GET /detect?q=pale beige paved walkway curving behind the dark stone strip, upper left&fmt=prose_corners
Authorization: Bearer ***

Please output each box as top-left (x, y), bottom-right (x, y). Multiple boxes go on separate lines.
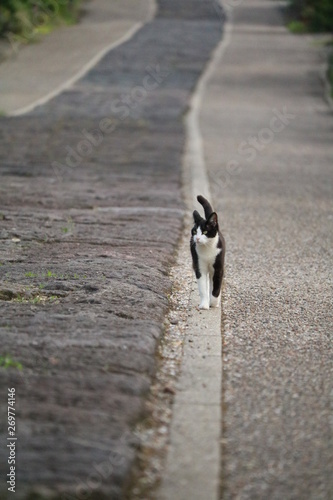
top-left (0, 0), bottom-right (155, 114)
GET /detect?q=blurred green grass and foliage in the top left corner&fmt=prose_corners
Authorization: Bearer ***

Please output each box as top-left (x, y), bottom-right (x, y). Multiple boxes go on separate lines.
top-left (0, 0), bottom-right (81, 42)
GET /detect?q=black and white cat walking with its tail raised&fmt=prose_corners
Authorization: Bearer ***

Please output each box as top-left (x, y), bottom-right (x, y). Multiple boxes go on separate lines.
top-left (191, 195), bottom-right (225, 309)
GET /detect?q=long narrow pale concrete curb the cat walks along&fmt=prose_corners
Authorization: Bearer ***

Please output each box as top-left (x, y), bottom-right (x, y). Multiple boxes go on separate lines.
top-left (158, 10), bottom-right (232, 500)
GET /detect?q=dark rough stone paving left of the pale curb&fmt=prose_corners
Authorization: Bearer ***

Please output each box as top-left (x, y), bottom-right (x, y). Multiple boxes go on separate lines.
top-left (0, 0), bottom-right (221, 499)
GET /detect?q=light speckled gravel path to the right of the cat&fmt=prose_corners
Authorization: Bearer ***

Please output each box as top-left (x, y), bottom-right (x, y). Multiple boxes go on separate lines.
top-left (201, 0), bottom-right (333, 500)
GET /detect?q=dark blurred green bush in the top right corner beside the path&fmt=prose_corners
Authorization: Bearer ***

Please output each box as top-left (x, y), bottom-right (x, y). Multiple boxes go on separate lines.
top-left (289, 0), bottom-right (333, 33)
